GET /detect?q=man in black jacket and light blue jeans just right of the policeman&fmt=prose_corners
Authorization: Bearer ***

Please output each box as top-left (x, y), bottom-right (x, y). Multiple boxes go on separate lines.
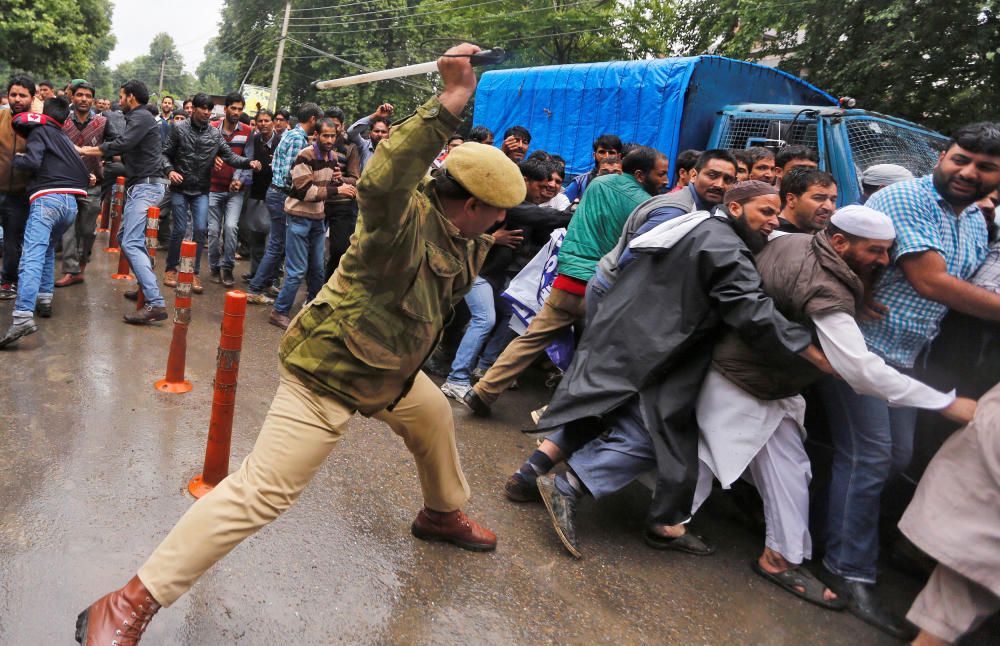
top-left (441, 159), bottom-right (572, 401)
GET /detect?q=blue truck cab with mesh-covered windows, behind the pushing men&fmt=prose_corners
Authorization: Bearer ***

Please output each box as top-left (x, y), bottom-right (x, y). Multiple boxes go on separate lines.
top-left (706, 103), bottom-right (948, 206)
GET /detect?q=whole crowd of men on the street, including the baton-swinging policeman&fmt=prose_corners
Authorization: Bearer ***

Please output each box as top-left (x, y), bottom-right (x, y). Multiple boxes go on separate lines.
top-left (0, 45), bottom-right (1000, 644)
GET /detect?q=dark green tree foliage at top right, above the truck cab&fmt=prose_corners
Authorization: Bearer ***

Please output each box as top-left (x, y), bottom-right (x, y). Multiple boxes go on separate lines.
top-left (669, 0), bottom-right (1000, 132)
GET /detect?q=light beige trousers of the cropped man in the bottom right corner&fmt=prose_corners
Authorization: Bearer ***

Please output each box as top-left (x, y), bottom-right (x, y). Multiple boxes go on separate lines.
top-left (906, 563), bottom-right (1000, 644)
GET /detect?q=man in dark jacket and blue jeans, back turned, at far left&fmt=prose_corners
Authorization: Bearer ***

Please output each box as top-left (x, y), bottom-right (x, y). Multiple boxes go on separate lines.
top-left (0, 97), bottom-right (90, 348)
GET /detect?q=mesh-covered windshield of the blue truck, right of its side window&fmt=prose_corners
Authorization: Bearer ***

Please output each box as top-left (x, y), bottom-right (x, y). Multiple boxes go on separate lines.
top-left (845, 118), bottom-right (947, 181)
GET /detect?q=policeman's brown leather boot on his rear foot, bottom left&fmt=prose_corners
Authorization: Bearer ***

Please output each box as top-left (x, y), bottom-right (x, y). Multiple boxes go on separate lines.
top-left (76, 576), bottom-right (160, 646)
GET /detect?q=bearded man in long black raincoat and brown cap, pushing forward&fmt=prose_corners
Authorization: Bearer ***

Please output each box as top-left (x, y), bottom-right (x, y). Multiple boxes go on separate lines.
top-left (528, 182), bottom-right (825, 558)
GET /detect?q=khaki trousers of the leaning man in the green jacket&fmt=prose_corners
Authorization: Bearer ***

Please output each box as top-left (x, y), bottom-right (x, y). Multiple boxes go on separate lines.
top-left (473, 289), bottom-right (586, 405)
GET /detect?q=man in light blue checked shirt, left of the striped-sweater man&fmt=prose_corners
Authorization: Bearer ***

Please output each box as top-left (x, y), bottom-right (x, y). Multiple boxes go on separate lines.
top-left (247, 103), bottom-right (323, 305)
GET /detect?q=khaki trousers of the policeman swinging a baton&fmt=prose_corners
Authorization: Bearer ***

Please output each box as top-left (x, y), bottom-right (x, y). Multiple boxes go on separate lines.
top-left (139, 368), bottom-right (469, 606)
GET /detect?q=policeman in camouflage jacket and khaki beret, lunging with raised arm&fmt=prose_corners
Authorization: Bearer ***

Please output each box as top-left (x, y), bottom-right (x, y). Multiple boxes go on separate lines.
top-left (76, 44), bottom-right (525, 645)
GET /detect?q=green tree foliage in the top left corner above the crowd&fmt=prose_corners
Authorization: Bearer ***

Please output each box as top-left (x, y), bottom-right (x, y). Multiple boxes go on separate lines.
top-left (0, 0), bottom-right (115, 82)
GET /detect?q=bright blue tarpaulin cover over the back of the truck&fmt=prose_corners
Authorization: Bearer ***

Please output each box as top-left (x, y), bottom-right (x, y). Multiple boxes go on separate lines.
top-left (473, 56), bottom-right (834, 177)
